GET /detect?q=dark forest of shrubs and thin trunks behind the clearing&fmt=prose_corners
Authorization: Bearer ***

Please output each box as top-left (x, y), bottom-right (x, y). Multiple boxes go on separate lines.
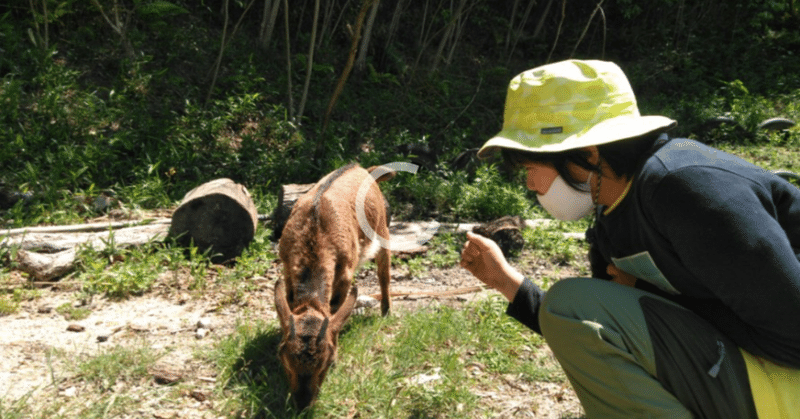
top-left (0, 0), bottom-right (800, 225)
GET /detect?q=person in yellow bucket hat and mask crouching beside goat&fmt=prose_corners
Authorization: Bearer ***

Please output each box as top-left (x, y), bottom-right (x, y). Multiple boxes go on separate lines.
top-left (461, 60), bottom-right (800, 419)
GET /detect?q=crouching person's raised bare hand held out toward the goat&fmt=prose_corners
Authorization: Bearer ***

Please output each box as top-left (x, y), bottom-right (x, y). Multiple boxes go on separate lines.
top-left (461, 232), bottom-right (525, 301)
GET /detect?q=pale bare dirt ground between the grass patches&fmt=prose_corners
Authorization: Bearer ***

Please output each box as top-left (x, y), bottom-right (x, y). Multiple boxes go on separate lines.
top-left (0, 235), bottom-right (583, 418)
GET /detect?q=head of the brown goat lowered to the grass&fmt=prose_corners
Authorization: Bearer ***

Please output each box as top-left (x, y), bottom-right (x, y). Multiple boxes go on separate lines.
top-left (275, 280), bottom-right (358, 410)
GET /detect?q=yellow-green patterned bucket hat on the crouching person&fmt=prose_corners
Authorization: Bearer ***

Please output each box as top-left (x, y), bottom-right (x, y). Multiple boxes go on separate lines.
top-left (478, 60), bottom-right (677, 157)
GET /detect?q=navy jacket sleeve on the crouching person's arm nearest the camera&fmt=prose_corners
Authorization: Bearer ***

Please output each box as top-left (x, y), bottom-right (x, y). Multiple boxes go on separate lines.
top-left (648, 167), bottom-right (800, 367)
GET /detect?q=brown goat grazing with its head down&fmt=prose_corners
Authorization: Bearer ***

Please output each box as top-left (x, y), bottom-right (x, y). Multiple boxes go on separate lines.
top-left (275, 164), bottom-right (395, 409)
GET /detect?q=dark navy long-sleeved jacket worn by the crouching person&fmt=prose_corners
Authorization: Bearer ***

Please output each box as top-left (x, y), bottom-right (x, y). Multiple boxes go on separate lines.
top-left (508, 139), bottom-right (800, 367)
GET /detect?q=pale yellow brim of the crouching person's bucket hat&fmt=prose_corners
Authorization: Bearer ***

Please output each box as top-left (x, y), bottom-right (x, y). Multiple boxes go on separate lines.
top-left (478, 115), bottom-right (678, 158)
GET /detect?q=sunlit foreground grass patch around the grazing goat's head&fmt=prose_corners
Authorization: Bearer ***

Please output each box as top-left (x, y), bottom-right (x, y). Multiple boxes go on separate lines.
top-left (209, 296), bottom-right (565, 418)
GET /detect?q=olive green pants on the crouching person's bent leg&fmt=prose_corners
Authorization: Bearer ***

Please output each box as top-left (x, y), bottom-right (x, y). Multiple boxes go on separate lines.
top-left (539, 278), bottom-right (756, 419)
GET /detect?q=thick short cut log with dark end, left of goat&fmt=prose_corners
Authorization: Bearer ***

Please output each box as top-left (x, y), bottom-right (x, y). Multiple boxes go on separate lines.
top-left (168, 178), bottom-right (258, 263)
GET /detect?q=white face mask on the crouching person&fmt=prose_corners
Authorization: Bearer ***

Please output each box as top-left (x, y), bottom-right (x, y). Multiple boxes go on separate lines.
top-left (536, 172), bottom-right (594, 221)
